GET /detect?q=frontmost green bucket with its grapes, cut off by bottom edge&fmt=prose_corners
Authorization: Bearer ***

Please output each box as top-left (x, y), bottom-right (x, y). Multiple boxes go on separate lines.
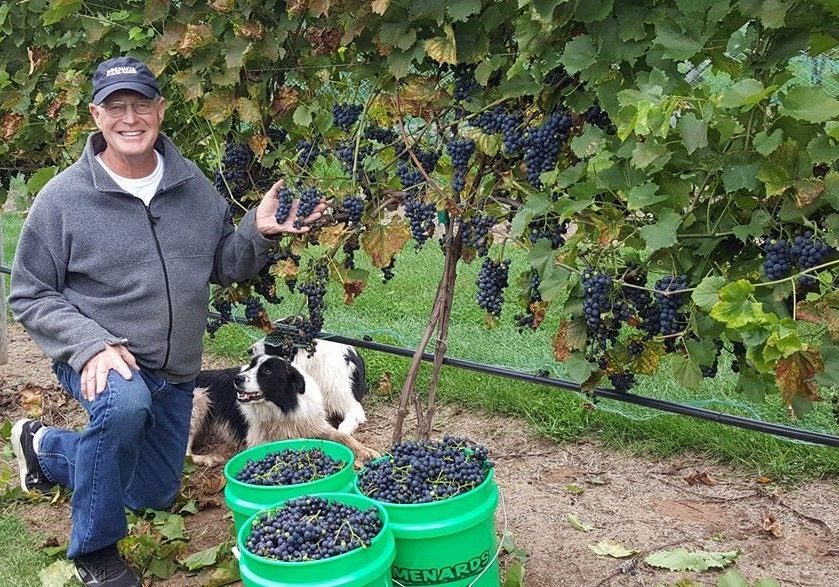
top-left (236, 493), bottom-right (396, 587)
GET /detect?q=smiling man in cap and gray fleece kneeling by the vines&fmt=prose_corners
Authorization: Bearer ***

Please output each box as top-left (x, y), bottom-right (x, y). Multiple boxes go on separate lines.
top-left (9, 57), bottom-right (324, 587)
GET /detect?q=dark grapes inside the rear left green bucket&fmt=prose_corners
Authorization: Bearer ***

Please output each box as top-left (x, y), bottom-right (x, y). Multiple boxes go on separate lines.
top-left (236, 448), bottom-right (347, 485)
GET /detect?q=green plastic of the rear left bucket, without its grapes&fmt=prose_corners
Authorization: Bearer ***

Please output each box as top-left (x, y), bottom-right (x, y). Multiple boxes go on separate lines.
top-left (224, 438), bottom-right (355, 532)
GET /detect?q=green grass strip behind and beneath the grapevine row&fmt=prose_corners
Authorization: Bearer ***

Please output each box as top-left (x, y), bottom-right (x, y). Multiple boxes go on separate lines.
top-left (4, 213), bottom-right (839, 482)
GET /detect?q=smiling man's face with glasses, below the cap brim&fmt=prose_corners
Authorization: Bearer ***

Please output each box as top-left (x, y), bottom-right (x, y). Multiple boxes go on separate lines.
top-left (89, 90), bottom-right (165, 158)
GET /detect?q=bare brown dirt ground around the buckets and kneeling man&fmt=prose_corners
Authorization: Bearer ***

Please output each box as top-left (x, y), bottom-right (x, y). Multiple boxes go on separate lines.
top-left (0, 325), bottom-right (839, 587)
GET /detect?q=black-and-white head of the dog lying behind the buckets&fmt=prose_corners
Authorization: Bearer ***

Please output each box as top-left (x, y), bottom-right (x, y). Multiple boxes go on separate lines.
top-left (233, 355), bottom-right (306, 413)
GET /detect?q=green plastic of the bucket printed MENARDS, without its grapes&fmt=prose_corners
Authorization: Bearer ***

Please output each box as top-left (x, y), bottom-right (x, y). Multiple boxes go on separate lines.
top-left (355, 469), bottom-right (501, 587)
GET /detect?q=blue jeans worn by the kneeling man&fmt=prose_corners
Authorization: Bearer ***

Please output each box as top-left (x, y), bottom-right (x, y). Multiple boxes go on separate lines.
top-left (38, 363), bottom-right (194, 559)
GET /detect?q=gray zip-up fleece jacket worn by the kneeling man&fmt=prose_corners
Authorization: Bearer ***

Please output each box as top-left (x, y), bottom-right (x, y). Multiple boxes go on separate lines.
top-left (9, 132), bottom-right (274, 383)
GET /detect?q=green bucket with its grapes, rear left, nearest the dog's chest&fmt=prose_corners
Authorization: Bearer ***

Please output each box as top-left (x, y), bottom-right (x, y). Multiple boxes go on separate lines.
top-left (224, 439), bottom-right (355, 532)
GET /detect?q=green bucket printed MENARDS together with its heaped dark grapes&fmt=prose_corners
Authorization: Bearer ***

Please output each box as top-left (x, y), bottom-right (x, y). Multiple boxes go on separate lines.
top-left (355, 437), bottom-right (501, 587)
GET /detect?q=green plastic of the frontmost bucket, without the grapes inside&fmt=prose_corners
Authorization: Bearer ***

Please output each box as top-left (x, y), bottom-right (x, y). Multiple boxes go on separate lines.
top-left (236, 493), bottom-right (395, 587)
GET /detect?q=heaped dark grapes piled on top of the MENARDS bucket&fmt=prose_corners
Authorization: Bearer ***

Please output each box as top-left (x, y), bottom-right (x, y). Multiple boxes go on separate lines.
top-left (358, 436), bottom-right (492, 503)
